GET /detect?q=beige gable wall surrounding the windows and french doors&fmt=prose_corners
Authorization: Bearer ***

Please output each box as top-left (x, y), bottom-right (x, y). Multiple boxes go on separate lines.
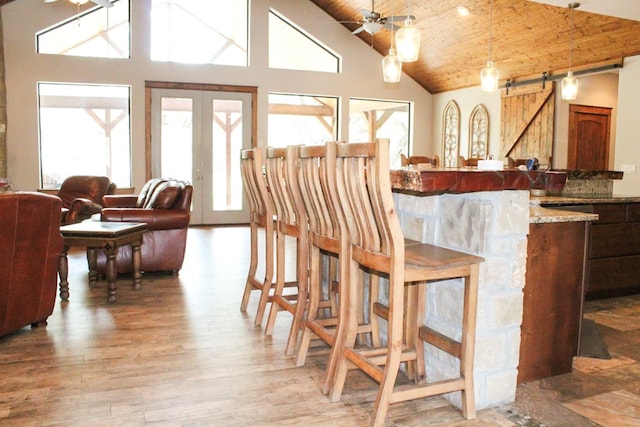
top-left (2, 0), bottom-right (432, 190)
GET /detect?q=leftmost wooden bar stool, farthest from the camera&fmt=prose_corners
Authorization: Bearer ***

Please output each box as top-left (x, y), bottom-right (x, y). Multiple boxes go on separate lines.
top-left (240, 148), bottom-right (275, 326)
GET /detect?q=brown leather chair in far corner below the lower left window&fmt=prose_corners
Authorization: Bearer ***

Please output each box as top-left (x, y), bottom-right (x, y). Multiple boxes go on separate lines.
top-left (57, 175), bottom-right (116, 225)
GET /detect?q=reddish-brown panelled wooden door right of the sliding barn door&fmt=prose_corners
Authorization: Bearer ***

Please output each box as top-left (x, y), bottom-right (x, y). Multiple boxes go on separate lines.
top-left (567, 105), bottom-right (611, 170)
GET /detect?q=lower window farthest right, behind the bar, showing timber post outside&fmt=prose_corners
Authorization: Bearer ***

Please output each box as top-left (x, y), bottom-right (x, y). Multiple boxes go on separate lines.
top-left (349, 98), bottom-right (411, 168)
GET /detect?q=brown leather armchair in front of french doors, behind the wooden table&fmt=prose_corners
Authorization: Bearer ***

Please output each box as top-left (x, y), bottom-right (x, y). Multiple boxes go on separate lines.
top-left (97, 178), bottom-right (193, 275)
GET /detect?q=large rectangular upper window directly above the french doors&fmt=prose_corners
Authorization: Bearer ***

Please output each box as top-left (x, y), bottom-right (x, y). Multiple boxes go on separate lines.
top-left (151, 0), bottom-right (249, 67)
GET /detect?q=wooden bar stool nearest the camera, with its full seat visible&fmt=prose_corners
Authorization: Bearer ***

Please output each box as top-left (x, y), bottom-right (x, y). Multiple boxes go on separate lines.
top-left (327, 140), bottom-right (484, 426)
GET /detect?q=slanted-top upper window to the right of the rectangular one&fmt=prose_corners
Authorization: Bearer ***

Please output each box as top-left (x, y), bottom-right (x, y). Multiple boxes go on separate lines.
top-left (269, 10), bottom-right (340, 73)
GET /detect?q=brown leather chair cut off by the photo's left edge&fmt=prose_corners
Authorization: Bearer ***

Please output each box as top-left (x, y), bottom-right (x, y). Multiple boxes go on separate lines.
top-left (0, 192), bottom-right (63, 336)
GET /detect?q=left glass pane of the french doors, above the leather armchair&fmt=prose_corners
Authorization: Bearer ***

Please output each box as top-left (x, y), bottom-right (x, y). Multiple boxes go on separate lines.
top-left (160, 97), bottom-right (193, 182)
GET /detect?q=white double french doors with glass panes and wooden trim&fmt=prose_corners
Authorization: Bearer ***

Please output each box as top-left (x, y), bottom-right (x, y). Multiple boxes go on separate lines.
top-left (151, 89), bottom-right (252, 225)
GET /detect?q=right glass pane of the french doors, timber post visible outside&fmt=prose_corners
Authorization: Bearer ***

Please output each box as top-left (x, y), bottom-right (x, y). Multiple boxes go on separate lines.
top-left (211, 99), bottom-right (243, 211)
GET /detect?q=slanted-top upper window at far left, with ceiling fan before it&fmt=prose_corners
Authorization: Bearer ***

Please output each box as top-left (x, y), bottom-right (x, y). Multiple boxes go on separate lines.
top-left (36, 0), bottom-right (130, 58)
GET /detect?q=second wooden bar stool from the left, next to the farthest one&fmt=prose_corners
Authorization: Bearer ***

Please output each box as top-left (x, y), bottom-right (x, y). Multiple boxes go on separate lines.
top-left (265, 148), bottom-right (309, 355)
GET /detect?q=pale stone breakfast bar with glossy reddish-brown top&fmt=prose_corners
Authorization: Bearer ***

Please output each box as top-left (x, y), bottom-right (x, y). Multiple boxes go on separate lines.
top-left (391, 168), bottom-right (597, 409)
